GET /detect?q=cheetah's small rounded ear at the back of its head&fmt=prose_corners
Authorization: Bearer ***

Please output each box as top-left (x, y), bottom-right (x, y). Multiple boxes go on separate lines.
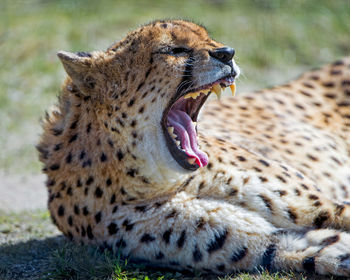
top-left (57, 51), bottom-right (95, 95)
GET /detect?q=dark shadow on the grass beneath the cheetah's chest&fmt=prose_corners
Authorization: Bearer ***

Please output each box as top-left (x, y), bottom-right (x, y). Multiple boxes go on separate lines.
top-left (0, 235), bottom-right (344, 280)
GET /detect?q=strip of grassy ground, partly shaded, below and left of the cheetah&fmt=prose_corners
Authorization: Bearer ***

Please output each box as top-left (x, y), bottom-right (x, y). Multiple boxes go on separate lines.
top-left (0, 211), bottom-right (329, 280)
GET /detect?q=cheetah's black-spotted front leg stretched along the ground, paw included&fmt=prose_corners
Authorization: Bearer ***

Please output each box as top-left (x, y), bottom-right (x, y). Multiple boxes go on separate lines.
top-left (93, 192), bottom-right (350, 275)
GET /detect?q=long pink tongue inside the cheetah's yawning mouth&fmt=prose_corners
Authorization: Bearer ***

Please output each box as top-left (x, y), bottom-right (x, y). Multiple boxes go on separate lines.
top-left (168, 109), bottom-right (209, 167)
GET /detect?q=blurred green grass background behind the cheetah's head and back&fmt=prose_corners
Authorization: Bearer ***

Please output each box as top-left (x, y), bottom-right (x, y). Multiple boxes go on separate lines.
top-left (0, 0), bottom-right (350, 173)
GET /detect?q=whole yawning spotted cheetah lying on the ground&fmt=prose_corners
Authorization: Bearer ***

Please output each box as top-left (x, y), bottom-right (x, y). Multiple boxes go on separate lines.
top-left (37, 20), bottom-right (350, 276)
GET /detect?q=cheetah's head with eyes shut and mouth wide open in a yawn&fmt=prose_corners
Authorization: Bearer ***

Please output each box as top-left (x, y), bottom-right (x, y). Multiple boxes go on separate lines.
top-left (58, 20), bottom-right (239, 184)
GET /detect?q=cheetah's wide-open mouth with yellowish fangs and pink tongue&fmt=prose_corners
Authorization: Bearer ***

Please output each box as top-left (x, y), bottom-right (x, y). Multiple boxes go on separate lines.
top-left (162, 76), bottom-right (236, 170)
